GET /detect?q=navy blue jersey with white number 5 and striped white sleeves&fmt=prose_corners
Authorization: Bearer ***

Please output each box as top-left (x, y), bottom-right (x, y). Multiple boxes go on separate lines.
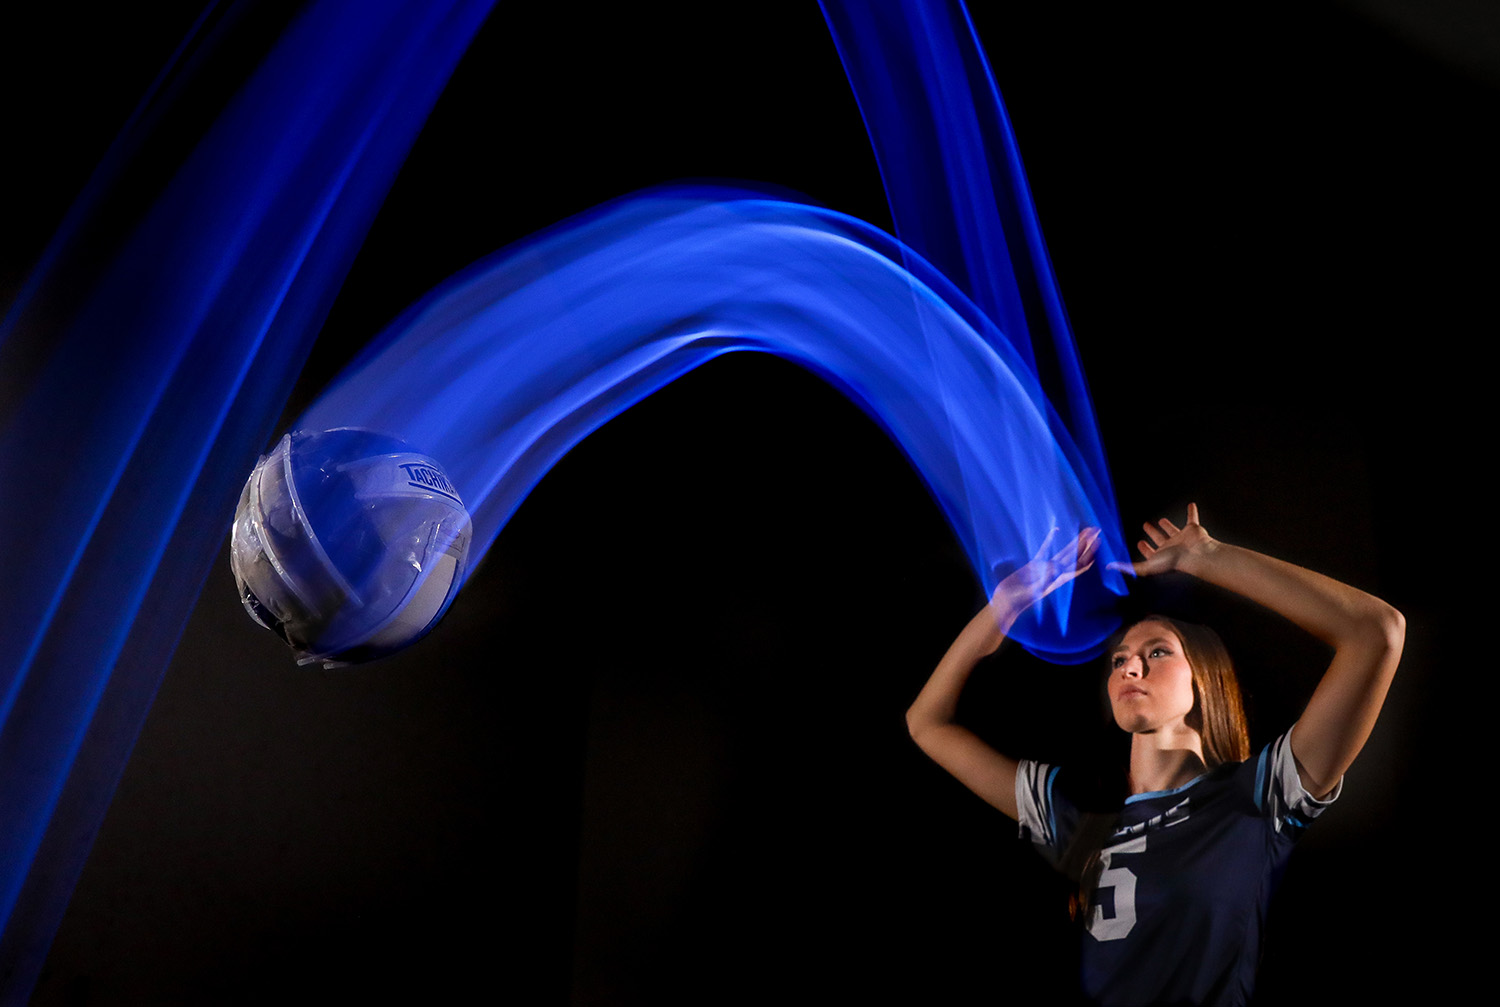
top-left (1016, 731), bottom-right (1343, 1007)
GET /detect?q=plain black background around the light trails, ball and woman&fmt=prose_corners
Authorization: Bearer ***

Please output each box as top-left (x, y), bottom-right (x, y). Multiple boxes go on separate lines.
top-left (3, 0), bottom-right (1482, 1004)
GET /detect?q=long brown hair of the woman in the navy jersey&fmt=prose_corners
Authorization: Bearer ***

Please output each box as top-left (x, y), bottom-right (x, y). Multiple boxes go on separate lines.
top-left (1059, 615), bottom-right (1250, 926)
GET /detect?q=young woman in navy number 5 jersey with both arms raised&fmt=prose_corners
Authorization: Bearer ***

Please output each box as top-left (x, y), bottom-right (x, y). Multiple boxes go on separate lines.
top-left (906, 504), bottom-right (1406, 1004)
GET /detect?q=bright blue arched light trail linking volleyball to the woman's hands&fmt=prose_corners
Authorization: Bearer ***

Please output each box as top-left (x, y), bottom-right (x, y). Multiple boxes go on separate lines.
top-left (299, 191), bottom-right (1124, 660)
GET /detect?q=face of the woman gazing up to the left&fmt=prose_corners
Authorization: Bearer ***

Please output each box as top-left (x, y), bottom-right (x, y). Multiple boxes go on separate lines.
top-left (1110, 623), bottom-right (1193, 734)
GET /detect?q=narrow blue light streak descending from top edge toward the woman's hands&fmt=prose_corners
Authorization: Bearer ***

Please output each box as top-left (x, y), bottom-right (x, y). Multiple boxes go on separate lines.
top-left (821, 0), bottom-right (1115, 527)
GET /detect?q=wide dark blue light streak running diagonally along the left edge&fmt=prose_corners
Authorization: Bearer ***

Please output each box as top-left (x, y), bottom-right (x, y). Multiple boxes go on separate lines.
top-left (0, 0), bottom-right (492, 1004)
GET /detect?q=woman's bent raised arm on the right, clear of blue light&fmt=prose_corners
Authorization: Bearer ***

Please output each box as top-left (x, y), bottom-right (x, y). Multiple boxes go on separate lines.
top-left (1134, 504), bottom-right (1406, 797)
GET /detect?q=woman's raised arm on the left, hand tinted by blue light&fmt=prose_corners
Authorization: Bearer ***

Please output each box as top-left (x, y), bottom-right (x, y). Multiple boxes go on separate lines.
top-left (906, 528), bottom-right (1100, 818)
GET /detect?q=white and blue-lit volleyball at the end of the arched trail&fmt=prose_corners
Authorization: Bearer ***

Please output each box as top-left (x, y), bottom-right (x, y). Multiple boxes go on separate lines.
top-left (230, 428), bottom-right (471, 665)
